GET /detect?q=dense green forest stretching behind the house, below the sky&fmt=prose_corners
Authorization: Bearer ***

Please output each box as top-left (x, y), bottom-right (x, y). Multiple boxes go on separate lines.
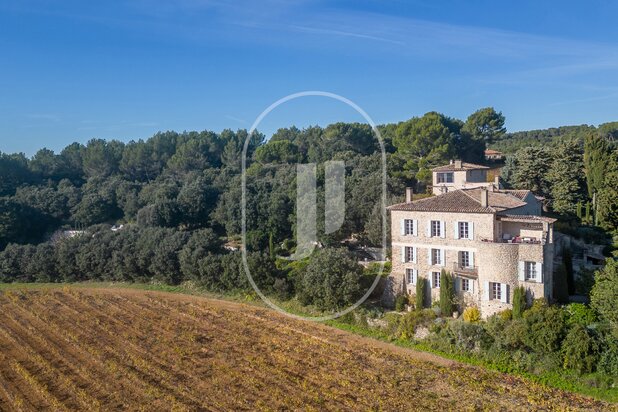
top-left (0, 108), bottom-right (618, 309)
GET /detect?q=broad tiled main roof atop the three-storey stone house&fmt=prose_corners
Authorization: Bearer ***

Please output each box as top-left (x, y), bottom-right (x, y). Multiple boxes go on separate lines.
top-left (388, 189), bottom-right (526, 213)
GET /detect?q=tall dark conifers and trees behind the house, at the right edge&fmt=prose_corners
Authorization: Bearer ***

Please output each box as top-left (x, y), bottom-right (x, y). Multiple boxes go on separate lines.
top-left (501, 123), bottom-right (618, 232)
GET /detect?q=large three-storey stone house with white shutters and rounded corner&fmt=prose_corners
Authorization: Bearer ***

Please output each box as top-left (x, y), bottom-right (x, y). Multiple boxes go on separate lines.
top-left (386, 166), bottom-right (555, 317)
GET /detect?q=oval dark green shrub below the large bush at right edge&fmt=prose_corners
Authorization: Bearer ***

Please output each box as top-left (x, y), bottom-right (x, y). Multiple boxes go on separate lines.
top-left (561, 324), bottom-right (599, 373)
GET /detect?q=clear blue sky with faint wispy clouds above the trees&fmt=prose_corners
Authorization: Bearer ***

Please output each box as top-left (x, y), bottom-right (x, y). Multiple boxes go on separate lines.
top-left (0, 0), bottom-right (618, 155)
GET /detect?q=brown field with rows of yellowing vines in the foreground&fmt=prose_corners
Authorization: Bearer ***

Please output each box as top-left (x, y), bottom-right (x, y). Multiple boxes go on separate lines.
top-left (0, 288), bottom-right (615, 411)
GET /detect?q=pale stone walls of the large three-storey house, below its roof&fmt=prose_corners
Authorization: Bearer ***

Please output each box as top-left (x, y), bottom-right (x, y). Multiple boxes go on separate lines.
top-left (390, 210), bottom-right (553, 317)
